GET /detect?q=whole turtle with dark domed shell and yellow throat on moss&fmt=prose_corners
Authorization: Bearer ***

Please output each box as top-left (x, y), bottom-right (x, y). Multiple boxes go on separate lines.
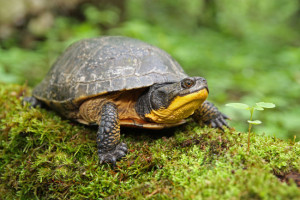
top-left (23, 36), bottom-right (228, 165)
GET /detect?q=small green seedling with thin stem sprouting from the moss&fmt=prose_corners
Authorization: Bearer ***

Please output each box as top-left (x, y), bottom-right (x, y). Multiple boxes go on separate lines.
top-left (226, 102), bottom-right (275, 153)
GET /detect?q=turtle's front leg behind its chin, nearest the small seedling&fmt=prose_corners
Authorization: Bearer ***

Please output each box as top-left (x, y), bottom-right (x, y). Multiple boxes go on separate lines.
top-left (192, 101), bottom-right (229, 131)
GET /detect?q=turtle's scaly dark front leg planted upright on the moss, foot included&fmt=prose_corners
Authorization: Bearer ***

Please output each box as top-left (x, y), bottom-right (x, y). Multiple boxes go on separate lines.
top-left (97, 102), bottom-right (127, 166)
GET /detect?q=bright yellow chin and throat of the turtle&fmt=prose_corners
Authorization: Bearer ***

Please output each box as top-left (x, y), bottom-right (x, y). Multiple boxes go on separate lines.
top-left (145, 89), bottom-right (208, 123)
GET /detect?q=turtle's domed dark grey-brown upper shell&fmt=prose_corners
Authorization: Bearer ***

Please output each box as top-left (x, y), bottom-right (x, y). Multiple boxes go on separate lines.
top-left (33, 36), bottom-right (187, 103)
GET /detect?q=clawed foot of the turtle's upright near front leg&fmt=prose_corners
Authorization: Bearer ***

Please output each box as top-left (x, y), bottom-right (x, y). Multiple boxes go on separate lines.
top-left (98, 143), bottom-right (128, 167)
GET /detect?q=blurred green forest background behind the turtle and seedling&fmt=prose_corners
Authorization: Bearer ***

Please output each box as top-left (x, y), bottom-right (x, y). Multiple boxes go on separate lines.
top-left (0, 0), bottom-right (300, 140)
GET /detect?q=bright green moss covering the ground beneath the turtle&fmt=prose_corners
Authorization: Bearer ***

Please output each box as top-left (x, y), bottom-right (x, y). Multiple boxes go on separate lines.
top-left (0, 84), bottom-right (300, 199)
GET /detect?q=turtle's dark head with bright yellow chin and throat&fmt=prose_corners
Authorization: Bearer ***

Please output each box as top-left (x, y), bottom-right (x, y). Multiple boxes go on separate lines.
top-left (136, 77), bottom-right (208, 123)
